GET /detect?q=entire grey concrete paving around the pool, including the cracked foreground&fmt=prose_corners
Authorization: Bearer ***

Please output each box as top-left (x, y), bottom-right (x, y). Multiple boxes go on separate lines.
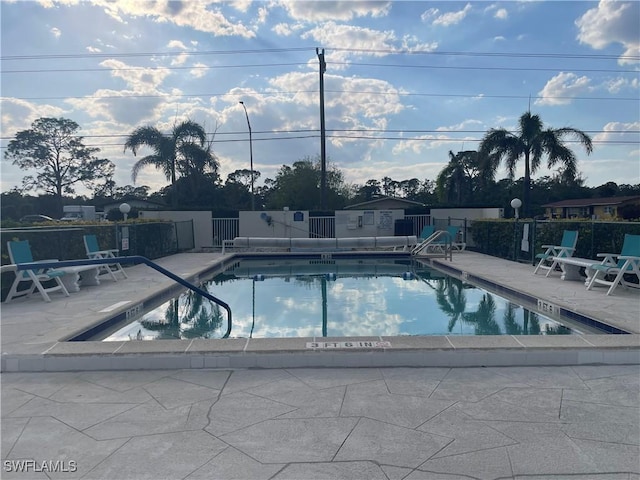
top-left (0, 252), bottom-right (640, 480)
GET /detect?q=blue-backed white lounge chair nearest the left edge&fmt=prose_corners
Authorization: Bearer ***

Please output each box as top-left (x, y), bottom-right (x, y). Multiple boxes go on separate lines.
top-left (5, 240), bottom-right (69, 303)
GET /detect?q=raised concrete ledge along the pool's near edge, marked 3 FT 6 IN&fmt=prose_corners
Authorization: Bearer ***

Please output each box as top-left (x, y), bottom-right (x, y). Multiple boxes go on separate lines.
top-left (0, 254), bottom-right (640, 372)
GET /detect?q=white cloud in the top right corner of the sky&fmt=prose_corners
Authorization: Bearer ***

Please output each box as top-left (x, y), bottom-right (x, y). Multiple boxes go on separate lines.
top-left (575, 0), bottom-right (640, 64)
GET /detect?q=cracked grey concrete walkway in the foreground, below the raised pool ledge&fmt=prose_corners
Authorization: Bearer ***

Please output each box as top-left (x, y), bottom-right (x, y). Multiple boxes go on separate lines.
top-left (2, 365), bottom-right (640, 480)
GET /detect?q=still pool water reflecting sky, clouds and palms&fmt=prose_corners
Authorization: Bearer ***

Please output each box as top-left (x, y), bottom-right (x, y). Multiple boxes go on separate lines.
top-left (104, 257), bottom-right (587, 341)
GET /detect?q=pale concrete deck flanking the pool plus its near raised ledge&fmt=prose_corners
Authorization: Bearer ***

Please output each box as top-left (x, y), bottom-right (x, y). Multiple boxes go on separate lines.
top-left (1, 252), bottom-right (640, 372)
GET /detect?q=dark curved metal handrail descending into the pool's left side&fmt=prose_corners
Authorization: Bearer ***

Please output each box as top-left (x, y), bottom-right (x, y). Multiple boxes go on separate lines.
top-left (16, 255), bottom-right (232, 338)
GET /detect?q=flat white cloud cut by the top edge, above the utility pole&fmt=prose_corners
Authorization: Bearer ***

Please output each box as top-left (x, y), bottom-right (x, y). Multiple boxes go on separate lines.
top-left (279, 0), bottom-right (392, 22)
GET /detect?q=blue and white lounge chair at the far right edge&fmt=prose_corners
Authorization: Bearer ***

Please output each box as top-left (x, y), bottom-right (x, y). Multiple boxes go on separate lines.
top-left (587, 234), bottom-right (640, 295)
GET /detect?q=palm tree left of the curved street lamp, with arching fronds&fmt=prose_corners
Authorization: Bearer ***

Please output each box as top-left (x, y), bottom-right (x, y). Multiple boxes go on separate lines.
top-left (124, 120), bottom-right (207, 207)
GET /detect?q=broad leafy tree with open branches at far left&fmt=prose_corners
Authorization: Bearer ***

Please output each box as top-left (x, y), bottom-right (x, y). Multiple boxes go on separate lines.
top-left (5, 118), bottom-right (115, 214)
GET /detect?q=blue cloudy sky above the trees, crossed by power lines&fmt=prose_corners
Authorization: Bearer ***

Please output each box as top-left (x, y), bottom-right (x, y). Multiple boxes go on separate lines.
top-left (0, 0), bottom-right (640, 197)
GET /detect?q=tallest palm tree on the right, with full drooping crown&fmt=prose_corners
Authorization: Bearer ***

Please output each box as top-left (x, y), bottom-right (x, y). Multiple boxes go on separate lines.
top-left (479, 112), bottom-right (593, 216)
